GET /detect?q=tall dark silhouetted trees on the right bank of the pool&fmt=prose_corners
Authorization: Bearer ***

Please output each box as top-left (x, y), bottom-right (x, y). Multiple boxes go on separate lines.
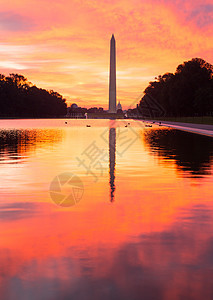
top-left (138, 58), bottom-right (213, 117)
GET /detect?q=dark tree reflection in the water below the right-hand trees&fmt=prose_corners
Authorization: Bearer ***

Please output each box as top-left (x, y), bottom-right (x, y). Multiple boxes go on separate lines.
top-left (144, 129), bottom-right (213, 177)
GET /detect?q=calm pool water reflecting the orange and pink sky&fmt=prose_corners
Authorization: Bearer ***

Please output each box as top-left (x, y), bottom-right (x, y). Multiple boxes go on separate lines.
top-left (0, 120), bottom-right (213, 300)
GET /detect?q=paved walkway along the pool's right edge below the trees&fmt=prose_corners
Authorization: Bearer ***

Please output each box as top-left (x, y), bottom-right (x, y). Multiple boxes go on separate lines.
top-left (148, 120), bottom-right (213, 137)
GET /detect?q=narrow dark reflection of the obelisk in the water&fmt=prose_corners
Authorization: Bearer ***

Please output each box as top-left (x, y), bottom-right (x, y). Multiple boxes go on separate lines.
top-left (109, 128), bottom-right (116, 202)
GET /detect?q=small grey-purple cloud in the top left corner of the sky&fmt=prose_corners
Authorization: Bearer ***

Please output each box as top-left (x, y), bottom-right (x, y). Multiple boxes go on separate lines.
top-left (0, 11), bottom-right (34, 32)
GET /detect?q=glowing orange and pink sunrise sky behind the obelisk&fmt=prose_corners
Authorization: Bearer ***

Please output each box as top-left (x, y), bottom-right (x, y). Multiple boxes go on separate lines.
top-left (0, 0), bottom-right (213, 108)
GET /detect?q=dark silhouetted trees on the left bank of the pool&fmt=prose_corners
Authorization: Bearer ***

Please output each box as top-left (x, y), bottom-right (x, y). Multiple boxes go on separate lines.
top-left (0, 74), bottom-right (67, 118)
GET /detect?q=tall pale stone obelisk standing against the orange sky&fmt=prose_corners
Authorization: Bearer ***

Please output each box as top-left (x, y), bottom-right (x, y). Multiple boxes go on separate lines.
top-left (109, 34), bottom-right (116, 113)
